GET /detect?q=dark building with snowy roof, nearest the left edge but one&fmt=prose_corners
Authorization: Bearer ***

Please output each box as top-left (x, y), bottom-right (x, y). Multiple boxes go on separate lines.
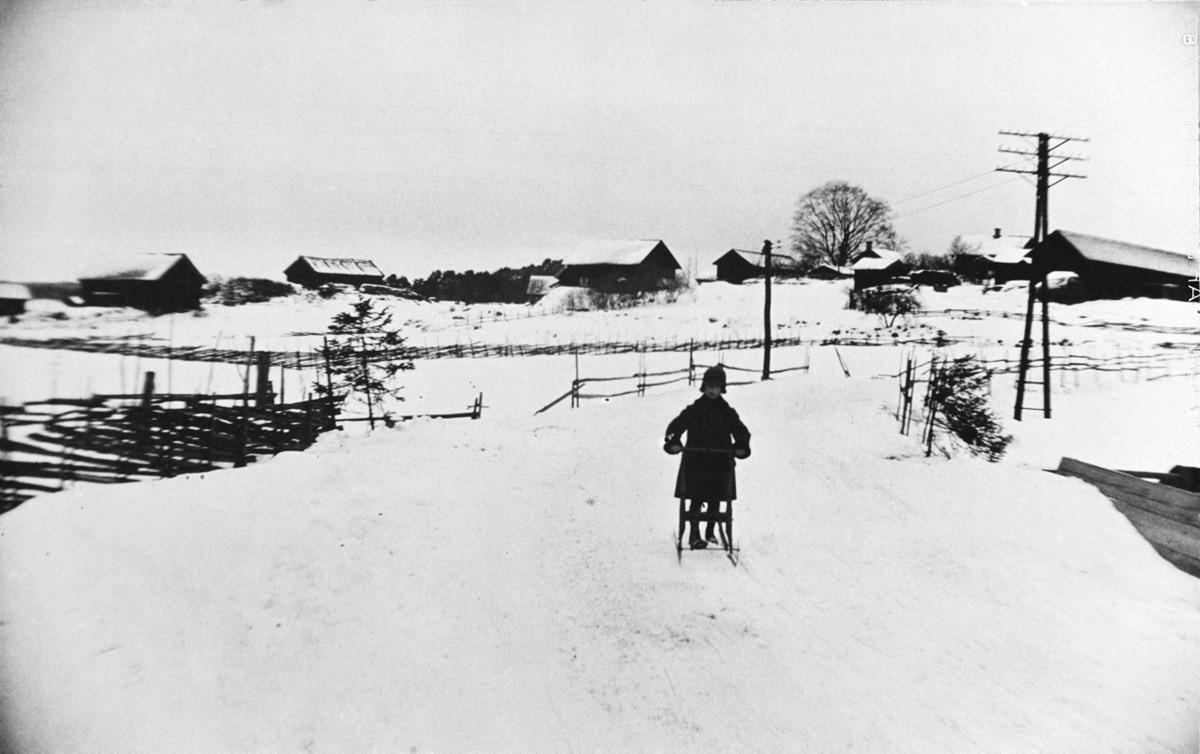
top-left (79, 253), bottom-right (206, 313)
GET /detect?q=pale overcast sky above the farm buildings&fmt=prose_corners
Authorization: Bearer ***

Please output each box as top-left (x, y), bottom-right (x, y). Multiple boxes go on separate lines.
top-left (0, 0), bottom-right (1200, 279)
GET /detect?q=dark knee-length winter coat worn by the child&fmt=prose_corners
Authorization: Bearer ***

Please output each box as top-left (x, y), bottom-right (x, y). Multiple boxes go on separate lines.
top-left (665, 396), bottom-right (750, 502)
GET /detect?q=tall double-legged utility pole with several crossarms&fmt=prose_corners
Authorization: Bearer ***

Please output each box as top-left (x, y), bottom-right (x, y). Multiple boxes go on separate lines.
top-left (996, 131), bottom-right (1087, 421)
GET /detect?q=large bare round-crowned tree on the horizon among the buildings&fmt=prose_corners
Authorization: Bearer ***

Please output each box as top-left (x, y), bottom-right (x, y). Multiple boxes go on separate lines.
top-left (792, 180), bottom-right (896, 267)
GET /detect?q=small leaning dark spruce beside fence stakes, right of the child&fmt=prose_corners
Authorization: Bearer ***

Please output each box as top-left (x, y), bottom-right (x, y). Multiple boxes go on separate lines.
top-left (930, 357), bottom-right (1013, 461)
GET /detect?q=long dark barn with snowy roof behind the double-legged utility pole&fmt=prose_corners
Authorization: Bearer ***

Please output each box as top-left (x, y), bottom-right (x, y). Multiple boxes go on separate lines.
top-left (1030, 231), bottom-right (1200, 300)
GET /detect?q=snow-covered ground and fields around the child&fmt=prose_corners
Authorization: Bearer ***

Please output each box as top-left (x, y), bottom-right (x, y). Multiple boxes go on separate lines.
top-left (0, 283), bottom-right (1200, 753)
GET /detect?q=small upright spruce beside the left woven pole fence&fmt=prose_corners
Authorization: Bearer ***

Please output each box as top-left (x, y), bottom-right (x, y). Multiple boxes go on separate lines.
top-left (313, 297), bottom-right (413, 408)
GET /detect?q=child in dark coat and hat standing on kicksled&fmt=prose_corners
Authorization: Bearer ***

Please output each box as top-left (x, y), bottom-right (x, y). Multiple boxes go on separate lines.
top-left (662, 365), bottom-right (750, 549)
